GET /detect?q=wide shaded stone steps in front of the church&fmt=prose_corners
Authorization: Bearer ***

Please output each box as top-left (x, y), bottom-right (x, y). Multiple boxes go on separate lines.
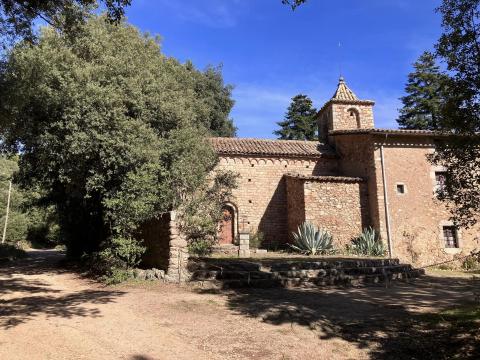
top-left (189, 258), bottom-right (424, 288)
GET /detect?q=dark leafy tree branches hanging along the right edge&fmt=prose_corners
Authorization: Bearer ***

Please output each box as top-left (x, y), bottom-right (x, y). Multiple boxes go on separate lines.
top-left (432, 0), bottom-right (480, 226)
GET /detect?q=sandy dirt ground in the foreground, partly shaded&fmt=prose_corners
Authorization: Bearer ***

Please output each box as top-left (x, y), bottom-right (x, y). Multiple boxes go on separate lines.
top-left (0, 251), bottom-right (480, 360)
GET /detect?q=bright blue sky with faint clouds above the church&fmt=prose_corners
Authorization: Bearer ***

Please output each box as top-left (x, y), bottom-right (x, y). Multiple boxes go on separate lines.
top-left (127, 0), bottom-right (441, 138)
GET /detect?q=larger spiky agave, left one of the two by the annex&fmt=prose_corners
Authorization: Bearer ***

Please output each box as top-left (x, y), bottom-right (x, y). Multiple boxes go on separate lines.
top-left (290, 222), bottom-right (333, 255)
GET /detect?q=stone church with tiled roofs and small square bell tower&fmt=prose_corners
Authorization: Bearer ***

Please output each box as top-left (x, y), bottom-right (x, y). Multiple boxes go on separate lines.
top-left (211, 78), bottom-right (480, 265)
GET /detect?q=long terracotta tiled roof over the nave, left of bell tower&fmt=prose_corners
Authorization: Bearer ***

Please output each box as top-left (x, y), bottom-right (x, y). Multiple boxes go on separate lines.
top-left (210, 137), bottom-right (335, 158)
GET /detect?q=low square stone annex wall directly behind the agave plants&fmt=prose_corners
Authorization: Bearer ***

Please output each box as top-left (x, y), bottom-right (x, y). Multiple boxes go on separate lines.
top-left (286, 176), bottom-right (369, 249)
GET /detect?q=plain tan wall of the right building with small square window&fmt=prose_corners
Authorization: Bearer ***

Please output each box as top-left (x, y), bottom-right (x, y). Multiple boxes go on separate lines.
top-left (375, 137), bottom-right (480, 265)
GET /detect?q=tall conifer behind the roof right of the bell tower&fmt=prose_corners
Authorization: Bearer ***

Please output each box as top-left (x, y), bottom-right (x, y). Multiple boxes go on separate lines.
top-left (397, 51), bottom-right (447, 130)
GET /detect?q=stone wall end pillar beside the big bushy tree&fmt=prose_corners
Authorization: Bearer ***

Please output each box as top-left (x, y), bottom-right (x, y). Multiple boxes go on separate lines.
top-left (141, 211), bottom-right (190, 283)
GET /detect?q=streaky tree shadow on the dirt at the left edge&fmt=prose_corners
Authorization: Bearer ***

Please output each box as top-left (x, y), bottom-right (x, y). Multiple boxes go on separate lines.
top-left (0, 251), bottom-right (124, 329)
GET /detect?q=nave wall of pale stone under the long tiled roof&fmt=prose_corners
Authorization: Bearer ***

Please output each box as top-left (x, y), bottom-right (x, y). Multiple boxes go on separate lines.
top-left (218, 156), bottom-right (337, 243)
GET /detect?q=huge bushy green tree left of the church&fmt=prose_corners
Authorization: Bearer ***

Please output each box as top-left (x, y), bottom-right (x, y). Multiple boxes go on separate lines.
top-left (0, 17), bottom-right (233, 267)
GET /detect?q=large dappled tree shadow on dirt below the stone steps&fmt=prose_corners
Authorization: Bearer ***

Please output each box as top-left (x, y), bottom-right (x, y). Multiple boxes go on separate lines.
top-left (199, 277), bottom-right (480, 360)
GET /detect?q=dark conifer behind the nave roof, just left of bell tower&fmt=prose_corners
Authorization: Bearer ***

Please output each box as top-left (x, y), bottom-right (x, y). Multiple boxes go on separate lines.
top-left (273, 94), bottom-right (317, 140)
